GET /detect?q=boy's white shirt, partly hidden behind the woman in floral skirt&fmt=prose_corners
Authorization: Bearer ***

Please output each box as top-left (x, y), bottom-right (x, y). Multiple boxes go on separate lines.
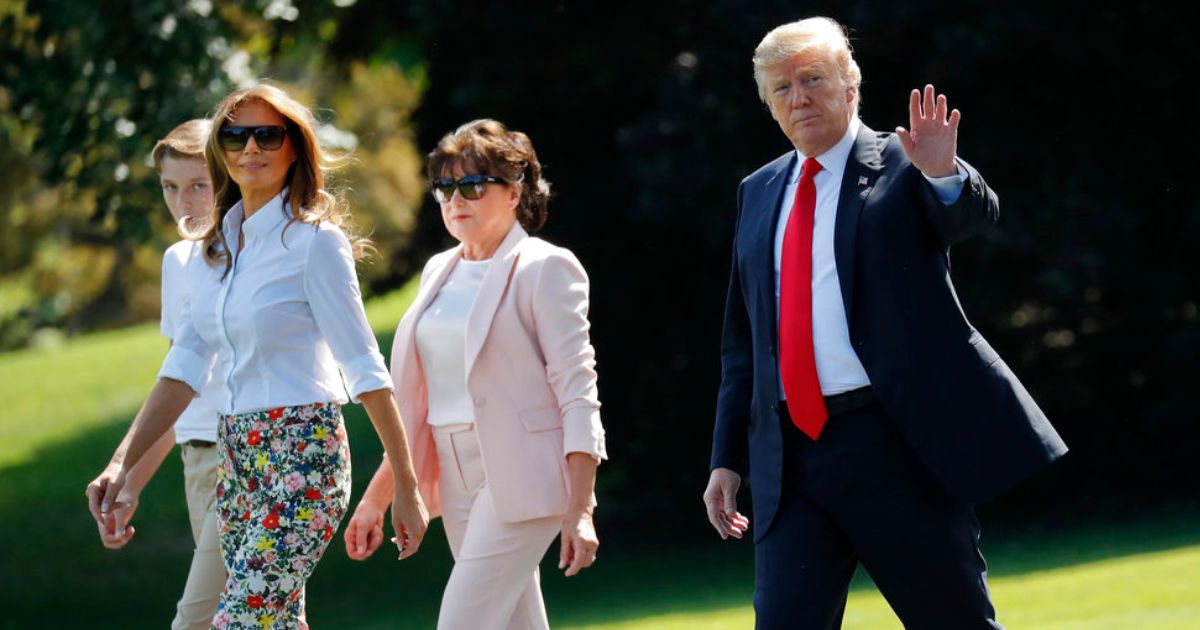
top-left (158, 240), bottom-right (222, 444)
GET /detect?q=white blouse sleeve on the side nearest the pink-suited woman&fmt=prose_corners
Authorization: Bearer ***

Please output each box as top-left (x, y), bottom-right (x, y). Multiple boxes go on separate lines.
top-left (304, 224), bottom-right (392, 402)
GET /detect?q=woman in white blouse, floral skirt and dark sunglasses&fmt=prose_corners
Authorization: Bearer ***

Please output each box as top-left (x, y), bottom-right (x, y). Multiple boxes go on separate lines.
top-left (88, 85), bottom-right (428, 629)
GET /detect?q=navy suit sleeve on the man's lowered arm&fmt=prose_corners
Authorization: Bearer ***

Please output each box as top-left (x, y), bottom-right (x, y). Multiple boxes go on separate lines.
top-left (709, 182), bottom-right (754, 476)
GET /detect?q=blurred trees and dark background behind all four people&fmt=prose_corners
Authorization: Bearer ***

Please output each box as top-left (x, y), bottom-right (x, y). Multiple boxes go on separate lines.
top-left (0, 0), bottom-right (1200, 532)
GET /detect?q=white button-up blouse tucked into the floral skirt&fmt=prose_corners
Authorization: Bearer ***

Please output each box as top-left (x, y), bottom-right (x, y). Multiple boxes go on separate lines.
top-left (158, 190), bottom-right (391, 414)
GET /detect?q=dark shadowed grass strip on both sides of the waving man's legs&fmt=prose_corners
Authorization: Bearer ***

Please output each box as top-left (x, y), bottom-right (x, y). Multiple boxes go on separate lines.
top-left (542, 506), bottom-right (1200, 626)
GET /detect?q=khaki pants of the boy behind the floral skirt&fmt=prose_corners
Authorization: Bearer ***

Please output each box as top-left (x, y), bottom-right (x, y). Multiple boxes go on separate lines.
top-left (170, 444), bottom-right (226, 630)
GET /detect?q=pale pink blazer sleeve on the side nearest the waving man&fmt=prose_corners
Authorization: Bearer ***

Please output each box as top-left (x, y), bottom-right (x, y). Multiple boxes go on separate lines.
top-left (534, 248), bottom-right (608, 460)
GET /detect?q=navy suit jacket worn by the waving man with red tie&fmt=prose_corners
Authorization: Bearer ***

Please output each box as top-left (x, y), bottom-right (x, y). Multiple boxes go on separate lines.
top-left (712, 125), bottom-right (1067, 540)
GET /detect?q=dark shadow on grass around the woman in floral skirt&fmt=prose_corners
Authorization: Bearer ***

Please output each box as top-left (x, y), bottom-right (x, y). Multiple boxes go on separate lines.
top-left (0, 396), bottom-right (451, 630)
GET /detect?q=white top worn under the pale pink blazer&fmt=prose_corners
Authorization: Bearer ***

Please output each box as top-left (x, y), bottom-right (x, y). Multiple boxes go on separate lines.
top-left (416, 258), bottom-right (491, 426)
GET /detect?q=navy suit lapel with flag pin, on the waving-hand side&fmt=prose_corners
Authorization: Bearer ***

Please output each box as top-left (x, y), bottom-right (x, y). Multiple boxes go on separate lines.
top-left (833, 125), bottom-right (883, 323)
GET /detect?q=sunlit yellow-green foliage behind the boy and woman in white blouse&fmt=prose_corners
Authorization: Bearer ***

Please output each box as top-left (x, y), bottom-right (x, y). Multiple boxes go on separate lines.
top-left (0, 0), bottom-right (424, 349)
